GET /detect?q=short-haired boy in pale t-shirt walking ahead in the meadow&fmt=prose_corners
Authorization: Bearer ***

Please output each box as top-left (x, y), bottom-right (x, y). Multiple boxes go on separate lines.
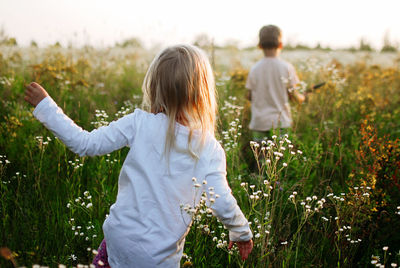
top-left (246, 25), bottom-right (305, 141)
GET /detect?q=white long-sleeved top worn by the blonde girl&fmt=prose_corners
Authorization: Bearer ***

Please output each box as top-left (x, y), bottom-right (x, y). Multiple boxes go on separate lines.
top-left (33, 97), bottom-right (252, 268)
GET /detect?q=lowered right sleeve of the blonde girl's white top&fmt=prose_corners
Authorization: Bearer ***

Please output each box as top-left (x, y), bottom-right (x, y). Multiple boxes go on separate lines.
top-left (206, 144), bottom-right (253, 241)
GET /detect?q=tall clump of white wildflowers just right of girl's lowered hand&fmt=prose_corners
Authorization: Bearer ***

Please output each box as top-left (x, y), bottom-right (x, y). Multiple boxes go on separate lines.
top-left (241, 134), bottom-right (315, 266)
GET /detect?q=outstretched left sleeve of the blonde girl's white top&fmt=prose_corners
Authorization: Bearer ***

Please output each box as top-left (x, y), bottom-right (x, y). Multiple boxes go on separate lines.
top-left (33, 96), bottom-right (136, 156)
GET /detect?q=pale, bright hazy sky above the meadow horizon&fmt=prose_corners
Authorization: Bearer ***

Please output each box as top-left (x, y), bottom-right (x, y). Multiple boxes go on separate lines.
top-left (0, 0), bottom-right (400, 48)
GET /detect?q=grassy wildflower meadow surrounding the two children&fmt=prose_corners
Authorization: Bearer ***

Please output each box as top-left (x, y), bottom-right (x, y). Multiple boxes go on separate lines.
top-left (0, 47), bottom-right (400, 267)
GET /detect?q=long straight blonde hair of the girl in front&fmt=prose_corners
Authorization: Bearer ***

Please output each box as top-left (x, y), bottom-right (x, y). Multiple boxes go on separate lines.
top-left (142, 45), bottom-right (217, 159)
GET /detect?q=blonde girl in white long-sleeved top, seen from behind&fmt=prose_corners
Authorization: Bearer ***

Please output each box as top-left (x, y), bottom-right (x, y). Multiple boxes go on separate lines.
top-left (25, 45), bottom-right (253, 267)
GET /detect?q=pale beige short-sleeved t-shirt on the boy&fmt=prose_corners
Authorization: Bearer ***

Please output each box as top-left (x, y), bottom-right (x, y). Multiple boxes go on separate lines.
top-left (246, 57), bottom-right (299, 131)
